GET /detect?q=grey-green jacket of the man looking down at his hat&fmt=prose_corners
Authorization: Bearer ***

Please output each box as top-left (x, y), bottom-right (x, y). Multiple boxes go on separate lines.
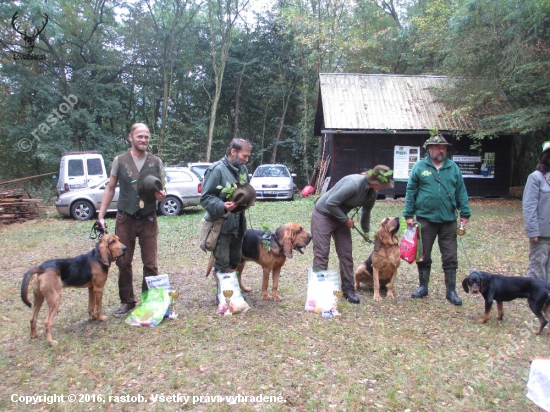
top-left (201, 156), bottom-right (249, 235)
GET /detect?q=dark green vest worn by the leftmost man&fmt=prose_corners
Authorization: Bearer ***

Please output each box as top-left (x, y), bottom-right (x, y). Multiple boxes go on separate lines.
top-left (117, 151), bottom-right (162, 215)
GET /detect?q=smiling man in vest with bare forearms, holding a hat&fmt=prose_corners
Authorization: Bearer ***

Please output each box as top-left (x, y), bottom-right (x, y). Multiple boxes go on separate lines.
top-left (97, 123), bottom-right (166, 318)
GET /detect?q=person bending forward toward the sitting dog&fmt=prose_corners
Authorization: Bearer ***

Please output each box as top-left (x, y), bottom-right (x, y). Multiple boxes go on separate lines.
top-left (311, 165), bottom-right (393, 303)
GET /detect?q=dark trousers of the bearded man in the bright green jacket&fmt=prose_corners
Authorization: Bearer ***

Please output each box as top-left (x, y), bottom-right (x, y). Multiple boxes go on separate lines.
top-left (416, 217), bottom-right (458, 270)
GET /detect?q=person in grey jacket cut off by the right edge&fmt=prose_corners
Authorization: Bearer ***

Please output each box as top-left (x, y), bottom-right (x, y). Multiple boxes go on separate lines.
top-left (523, 141), bottom-right (550, 283)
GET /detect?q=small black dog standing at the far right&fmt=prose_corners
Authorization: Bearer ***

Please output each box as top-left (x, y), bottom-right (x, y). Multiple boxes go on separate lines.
top-left (462, 270), bottom-right (550, 335)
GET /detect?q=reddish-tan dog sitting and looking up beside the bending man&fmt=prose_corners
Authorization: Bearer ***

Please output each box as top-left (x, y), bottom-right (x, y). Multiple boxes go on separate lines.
top-left (355, 217), bottom-right (401, 302)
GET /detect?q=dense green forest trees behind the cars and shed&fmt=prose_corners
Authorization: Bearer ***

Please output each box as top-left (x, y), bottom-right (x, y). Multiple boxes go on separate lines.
top-left (0, 0), bottom-right (550, 191)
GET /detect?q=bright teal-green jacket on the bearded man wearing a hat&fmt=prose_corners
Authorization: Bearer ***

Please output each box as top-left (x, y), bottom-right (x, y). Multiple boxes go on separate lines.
top-left (403, 155), bottom-right (472, 223)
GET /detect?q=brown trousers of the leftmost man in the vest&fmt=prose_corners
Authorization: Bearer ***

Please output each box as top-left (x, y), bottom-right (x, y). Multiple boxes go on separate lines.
top-left (115, 212), bottom-right (158, 304)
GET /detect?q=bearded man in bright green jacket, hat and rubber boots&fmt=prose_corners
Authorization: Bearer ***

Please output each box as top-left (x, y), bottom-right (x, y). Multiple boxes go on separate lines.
top-left (403, 135), bottom-right (472, 305)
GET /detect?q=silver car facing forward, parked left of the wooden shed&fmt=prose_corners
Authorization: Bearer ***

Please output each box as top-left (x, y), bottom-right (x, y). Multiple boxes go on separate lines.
top-left (250, 164), bottom-right (296, 200)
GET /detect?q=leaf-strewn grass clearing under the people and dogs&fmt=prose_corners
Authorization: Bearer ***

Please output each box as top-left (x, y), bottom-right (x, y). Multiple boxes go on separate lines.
top-left (0, 199), bottom-right (550, 411)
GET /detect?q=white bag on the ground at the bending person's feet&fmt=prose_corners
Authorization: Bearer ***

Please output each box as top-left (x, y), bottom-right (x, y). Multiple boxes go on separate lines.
top-left (305, 268), bottom-right (340, 317)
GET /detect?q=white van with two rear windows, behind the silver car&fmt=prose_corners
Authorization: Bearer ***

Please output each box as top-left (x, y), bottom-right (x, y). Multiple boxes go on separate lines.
top-left (57, 150), bottom-right (108, 196)
